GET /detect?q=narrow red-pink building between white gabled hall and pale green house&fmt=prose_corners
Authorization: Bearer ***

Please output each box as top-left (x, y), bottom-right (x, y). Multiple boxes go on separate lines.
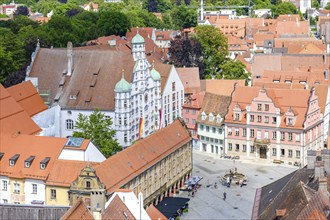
top-left (182, 92), bottom-right (205, 146)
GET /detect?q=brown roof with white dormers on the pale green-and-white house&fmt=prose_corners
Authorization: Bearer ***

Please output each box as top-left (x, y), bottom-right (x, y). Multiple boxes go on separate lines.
top-left (197, 93), bottom-right (231, 126)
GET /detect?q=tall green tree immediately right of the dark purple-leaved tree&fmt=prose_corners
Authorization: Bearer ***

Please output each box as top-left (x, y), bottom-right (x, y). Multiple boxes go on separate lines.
top-left (195, 25), bottom-right (228, 78)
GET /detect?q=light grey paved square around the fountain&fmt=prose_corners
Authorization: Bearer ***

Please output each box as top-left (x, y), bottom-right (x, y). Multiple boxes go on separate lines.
top-left (178, 151), bottom-right (297, 219)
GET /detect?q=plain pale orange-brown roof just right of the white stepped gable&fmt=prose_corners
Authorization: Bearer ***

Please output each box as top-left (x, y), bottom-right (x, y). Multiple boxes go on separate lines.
top-left (176, 67), bottom-right (200, 93)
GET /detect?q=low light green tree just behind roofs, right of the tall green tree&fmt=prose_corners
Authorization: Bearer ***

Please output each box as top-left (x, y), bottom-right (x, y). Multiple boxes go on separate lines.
top-left (215, 59), bottom-right (249, 80)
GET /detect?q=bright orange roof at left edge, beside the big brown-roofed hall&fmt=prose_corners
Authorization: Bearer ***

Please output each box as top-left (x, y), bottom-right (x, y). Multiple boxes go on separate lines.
top-left (7, 81), bottom-right (47, 117)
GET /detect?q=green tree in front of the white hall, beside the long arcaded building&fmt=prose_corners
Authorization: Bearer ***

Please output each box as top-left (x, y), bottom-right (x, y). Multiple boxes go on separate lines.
top-left (73, 110), bottom-right (121, 158)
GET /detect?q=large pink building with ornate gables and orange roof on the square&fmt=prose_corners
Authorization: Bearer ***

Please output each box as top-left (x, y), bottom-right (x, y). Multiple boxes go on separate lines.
top-left (225, 87), bottom-right (323, 165)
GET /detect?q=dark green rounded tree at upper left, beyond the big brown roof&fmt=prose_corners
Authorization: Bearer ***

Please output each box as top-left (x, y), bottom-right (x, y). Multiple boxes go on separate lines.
top-left (97, 10), bottom-right (131, 36)
